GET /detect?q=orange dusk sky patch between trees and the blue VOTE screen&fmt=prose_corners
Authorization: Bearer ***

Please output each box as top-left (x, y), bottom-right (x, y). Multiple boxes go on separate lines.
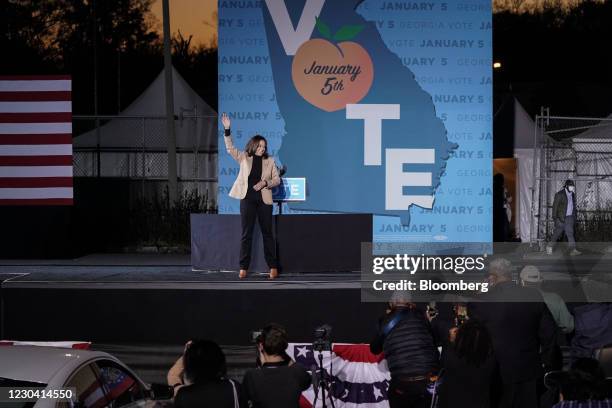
top-left (152, 0), bottom-right (217, 45)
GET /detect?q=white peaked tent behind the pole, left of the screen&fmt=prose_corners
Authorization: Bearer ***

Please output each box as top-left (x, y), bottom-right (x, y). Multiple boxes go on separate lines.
top-left (73, 67), bottom-right (217, 182)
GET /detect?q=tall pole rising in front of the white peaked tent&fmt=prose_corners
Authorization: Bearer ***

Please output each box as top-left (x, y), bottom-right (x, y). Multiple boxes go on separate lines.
top-left (163, 0), bottom-right (178, 206)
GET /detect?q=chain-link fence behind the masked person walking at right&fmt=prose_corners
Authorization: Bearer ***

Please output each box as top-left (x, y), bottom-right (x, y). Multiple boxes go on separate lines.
top-left (531, 110), bottom-right (612, 242)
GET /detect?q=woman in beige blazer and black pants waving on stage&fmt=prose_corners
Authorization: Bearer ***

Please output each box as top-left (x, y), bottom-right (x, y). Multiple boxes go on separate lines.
top-left (221, 113), bottom-right (280, 279)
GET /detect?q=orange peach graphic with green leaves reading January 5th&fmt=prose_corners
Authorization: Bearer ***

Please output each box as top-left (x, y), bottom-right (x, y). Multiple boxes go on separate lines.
top-left (291, 19), bottom-right (374, 112)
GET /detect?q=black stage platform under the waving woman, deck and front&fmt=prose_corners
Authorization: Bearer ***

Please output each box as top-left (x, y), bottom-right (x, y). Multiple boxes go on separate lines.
top-left (0, 253), bottom-right (612, 345)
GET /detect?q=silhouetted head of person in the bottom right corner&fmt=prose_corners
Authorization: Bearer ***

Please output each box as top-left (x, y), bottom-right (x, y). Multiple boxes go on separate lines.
top-left (544, 358), bottom-right (612, 408)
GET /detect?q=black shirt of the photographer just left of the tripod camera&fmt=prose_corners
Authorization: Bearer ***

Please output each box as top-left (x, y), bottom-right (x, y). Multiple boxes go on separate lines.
top-left (242, 362), bottom-right (311, 408)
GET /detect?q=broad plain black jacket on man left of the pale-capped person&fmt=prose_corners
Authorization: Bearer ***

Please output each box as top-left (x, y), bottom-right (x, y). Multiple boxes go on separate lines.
top-left (469, 282), bottom-right (557, 384)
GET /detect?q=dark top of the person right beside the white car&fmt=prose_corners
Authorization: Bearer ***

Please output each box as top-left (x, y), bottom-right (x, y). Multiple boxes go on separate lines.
top-left (174, 380), bottom-right (248, 408)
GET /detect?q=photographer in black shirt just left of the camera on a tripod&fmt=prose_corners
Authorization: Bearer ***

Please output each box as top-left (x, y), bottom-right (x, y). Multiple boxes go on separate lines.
top-left (243, 324), bottom-right (311, 408)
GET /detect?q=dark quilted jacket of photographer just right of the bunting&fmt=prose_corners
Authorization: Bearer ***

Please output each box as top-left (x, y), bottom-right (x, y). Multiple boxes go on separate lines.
top-left (370, 309), bottom-right (439, 378)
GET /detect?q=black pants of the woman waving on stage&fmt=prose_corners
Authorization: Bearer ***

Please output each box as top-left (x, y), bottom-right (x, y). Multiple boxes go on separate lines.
top-left (240, 198), bottom-right (278, 269)
